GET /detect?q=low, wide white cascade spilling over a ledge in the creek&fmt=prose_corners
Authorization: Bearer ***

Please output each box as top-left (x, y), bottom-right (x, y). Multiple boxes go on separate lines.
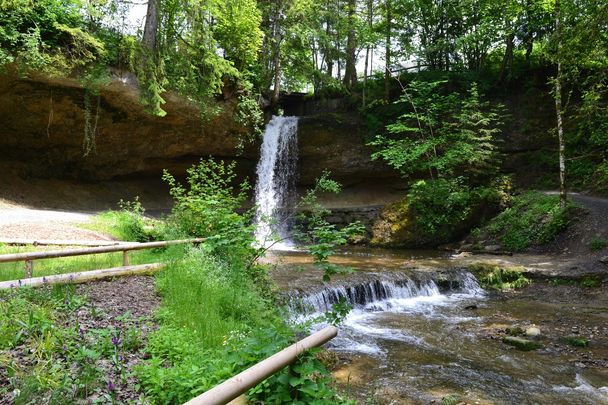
top-left (290, 271), bottom-right (485, 355)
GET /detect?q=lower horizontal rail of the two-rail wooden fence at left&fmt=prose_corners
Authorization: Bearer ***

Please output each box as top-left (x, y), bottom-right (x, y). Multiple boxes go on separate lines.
top-left (0, 263), bottom-right (166, 289)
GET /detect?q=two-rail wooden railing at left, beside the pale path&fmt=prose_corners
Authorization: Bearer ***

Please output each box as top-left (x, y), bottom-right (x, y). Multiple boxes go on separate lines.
top-left (0, 238), bottom-right (205, 288)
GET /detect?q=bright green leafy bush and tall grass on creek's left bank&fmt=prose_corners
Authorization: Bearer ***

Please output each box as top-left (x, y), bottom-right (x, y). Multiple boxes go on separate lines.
top-left (137, 163), bottom-right (352, 404)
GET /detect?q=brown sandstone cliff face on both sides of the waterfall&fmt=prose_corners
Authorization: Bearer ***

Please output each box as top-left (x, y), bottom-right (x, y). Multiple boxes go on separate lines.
top-left (0, 75), bottom-right (398, 187)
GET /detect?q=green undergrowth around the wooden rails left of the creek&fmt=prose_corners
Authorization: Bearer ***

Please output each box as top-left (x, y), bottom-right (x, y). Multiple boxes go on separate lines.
top-left (0, 160), bottom-right (352, 404)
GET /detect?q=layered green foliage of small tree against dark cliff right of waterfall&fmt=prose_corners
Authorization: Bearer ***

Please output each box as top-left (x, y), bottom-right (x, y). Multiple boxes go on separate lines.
top-left (369, 81), bottom-right (501, 178)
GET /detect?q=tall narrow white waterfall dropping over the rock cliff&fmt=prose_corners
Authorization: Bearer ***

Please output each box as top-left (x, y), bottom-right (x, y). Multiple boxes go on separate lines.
top-left (255, 116), bottom-right (298, 246)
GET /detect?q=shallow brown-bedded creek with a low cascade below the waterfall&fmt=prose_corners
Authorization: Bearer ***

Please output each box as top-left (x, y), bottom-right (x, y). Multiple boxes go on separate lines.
top-left (271, 250), bottom-right (608, 404)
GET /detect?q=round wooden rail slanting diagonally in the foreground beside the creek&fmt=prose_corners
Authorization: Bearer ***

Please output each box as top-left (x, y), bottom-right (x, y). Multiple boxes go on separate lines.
top-left (184, 326), bottom-right (338, 405)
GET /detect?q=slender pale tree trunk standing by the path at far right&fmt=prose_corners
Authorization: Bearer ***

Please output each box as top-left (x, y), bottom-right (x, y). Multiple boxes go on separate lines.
top-left (555, 0), bottom-right (568, 208)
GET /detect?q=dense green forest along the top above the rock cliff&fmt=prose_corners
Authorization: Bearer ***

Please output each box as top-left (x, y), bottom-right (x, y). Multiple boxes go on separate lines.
top-left (0, 0), bottom-right (608, 194)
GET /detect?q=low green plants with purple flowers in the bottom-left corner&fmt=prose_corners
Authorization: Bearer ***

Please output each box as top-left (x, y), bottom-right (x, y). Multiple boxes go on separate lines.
top-left (0, 286), bottom-right (141, 403)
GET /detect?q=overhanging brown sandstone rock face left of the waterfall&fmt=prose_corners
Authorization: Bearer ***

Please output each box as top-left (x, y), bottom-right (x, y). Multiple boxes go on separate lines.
top-left (0, 72), bottom-right (257, 181)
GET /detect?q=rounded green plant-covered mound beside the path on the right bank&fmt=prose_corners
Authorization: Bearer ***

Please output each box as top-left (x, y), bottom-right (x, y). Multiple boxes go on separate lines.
top-left (485, 192), bottom-right (574, 251)
